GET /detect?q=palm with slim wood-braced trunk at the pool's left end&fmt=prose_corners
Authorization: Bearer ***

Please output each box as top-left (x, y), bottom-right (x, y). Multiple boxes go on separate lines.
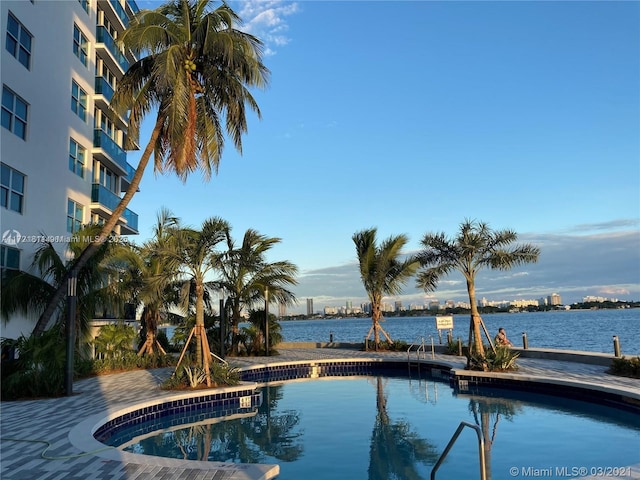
top-left (158, 217), bottom-right (231, 378)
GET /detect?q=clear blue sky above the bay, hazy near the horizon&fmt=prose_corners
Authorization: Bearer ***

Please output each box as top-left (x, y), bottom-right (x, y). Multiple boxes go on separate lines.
top-left (128, 0), bottom-right (640, 313)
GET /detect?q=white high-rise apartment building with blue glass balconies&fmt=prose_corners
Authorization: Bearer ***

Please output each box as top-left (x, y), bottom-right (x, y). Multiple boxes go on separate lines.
top-left (0, 0), bottom-right (138, 338)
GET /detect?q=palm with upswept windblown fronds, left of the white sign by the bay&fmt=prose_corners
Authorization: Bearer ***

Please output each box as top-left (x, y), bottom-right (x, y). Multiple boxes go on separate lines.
top-left (352, 228), bottom-right (419, 350)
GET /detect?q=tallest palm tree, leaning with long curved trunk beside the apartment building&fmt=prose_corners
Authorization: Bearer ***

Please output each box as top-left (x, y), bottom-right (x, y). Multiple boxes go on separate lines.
top-left (33, 0), bottom-right (269, 335)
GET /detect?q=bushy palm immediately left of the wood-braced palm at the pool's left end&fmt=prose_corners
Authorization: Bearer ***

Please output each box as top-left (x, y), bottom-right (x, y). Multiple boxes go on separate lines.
top-left (114, 208), bottom-right (178, 355)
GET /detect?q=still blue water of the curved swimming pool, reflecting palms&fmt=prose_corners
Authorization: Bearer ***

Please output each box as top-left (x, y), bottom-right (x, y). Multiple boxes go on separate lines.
top-left (124, 376), bottom-right (640, 480)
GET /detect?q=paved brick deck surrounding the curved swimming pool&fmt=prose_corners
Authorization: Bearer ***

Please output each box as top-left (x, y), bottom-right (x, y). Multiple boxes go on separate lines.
top-left (0, 348), bottom-right (640, 480)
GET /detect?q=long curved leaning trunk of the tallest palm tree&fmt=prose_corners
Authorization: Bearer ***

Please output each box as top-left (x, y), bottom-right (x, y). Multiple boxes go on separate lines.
top-left (32, 116), bottom-right (162, 336)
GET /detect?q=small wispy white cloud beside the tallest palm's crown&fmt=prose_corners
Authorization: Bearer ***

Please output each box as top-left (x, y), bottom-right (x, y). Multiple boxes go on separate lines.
top-left (238, 0), bottom-right (300, 56)
